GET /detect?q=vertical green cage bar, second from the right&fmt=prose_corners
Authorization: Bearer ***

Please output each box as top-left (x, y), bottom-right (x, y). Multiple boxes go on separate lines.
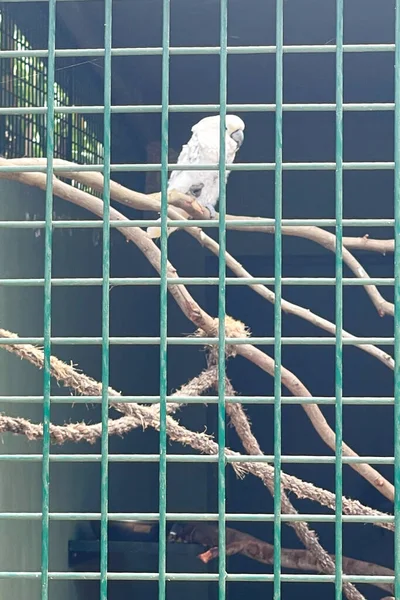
top-left (335, 0), bottom-right (343, 600)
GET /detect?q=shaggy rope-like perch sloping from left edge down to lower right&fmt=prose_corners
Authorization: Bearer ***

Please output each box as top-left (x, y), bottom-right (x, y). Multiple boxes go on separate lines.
top-left (0, 329), bottom-right (394, 531)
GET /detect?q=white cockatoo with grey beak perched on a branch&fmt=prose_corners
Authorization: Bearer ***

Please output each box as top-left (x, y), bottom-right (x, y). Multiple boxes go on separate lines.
top-left (147, 115), bottom-right (245, 238)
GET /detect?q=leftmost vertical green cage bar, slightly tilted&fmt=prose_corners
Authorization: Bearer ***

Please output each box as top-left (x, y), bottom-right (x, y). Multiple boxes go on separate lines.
top-left (41, 0), bottom-right (56, 600)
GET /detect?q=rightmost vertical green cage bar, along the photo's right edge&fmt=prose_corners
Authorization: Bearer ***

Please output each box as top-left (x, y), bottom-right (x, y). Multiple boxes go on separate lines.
top-left (394, 0), bottom-right (400, 598)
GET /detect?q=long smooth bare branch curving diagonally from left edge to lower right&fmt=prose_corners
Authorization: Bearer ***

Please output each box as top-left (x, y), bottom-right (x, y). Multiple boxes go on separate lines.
top-left (0, 159), bottom-right (394, 502)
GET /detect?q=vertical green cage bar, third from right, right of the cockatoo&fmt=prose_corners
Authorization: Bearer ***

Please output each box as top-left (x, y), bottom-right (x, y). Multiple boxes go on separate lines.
top-left (274, 0), bottom-right (283, 600)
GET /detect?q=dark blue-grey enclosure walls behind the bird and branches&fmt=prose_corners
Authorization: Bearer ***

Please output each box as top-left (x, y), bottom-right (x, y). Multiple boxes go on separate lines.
top-left (0, 0), bottom-right (394, 600)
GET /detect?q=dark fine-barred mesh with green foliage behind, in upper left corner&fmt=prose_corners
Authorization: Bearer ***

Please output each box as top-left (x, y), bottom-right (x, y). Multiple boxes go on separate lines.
top-left (0, 4), bottom-right (104, 197)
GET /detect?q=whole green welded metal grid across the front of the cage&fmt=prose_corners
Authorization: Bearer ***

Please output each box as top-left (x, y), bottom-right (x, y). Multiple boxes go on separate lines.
top-left (0, 0), bottom-right (400, 600)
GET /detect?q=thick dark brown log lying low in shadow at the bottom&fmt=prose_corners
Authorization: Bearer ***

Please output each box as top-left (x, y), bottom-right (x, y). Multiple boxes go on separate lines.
top-left (171, 521), bottom-right (394, 597)
